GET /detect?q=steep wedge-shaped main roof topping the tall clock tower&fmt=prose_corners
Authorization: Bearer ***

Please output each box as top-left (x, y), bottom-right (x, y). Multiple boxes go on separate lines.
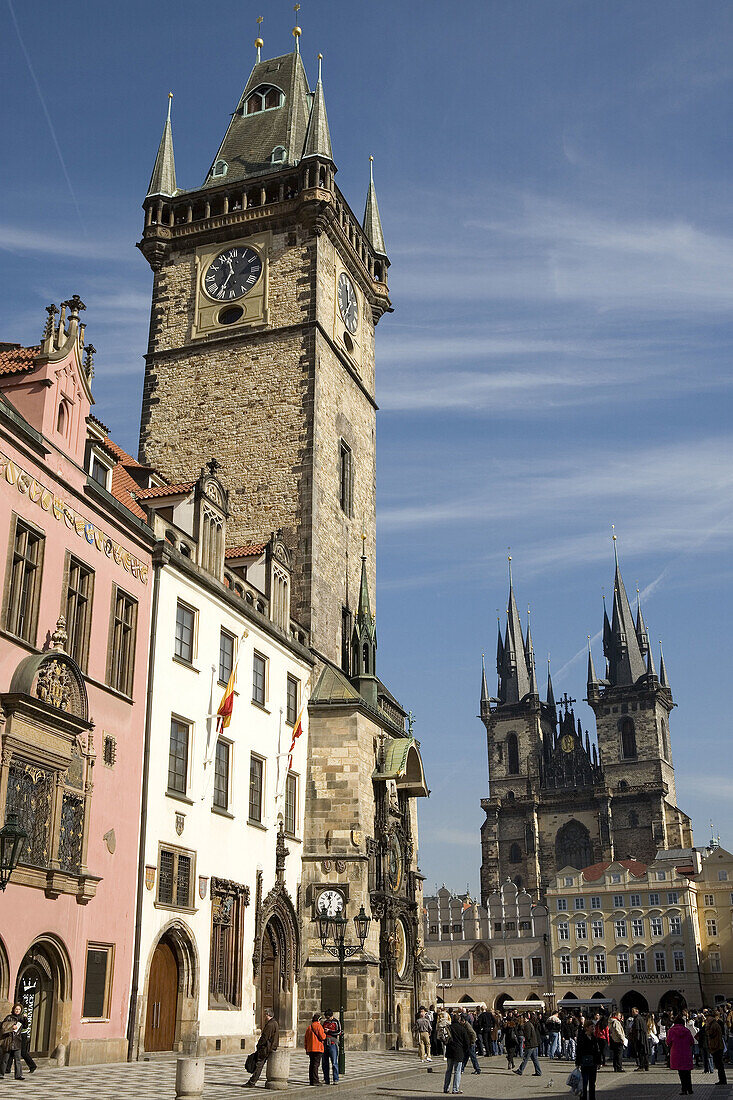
top-left (204, 51), bottom-right (310, 187)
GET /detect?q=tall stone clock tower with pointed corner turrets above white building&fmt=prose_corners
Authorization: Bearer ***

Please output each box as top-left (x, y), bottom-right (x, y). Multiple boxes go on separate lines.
top-left (139, 36), bottom-right (392, 667)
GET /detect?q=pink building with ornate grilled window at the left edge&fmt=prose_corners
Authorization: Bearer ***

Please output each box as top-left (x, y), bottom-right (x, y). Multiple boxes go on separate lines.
top-left (0, 296), bottom-right (157, 1064)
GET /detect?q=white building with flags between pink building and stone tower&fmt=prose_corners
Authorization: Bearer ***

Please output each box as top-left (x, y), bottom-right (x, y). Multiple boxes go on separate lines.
top-left (131, 463), bottom-right (313, 1057)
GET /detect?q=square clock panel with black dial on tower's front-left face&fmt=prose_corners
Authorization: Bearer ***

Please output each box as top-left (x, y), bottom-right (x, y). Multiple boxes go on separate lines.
top-left (192, 232), bottom-right (271, 339)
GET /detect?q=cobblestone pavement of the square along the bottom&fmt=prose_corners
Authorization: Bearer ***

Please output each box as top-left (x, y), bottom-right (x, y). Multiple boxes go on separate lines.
top-left (1, 1051), bottom-right (733, 1100)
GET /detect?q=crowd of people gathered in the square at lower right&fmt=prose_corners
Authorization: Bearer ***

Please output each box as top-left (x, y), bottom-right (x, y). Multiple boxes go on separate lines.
top-left (414, 1003), bottom-right (733, 1100)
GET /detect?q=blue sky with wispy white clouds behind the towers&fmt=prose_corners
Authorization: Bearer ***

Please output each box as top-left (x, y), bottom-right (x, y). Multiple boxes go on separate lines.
top-left (0, 0), bottom-right (733, 890)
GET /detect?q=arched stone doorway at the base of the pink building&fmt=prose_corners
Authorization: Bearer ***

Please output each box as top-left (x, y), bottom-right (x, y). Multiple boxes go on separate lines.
top-left (14, 936), bottom-right (72, 1058)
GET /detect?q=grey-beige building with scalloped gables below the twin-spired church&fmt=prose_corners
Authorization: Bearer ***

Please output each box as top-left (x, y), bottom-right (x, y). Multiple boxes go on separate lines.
top-left (424, 882), bottom-right (551, 1009)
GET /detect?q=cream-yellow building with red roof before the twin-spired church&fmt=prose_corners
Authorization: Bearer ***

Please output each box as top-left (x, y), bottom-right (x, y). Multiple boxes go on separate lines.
top-left (547, 849), bottom-right (699, 1012)
